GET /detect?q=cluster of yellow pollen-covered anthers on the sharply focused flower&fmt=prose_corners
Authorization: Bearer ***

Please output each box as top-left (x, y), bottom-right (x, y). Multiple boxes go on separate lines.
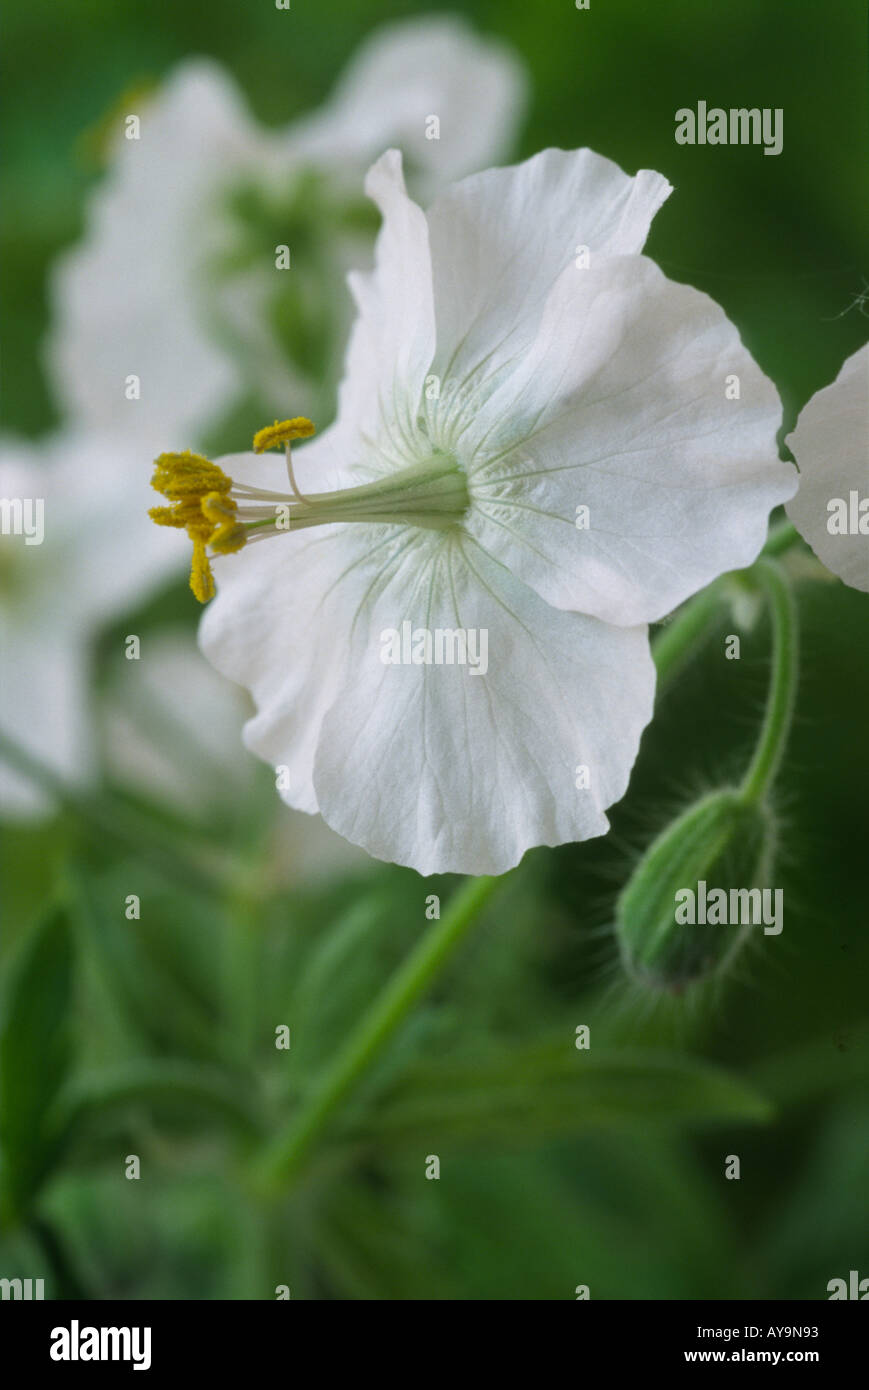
top-left (149, 416), bottom-right (314, 603)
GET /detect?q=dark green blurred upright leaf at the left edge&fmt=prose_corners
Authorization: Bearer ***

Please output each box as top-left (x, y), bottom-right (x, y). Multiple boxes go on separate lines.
top-left (0, 904), bottom-right (72, 1215)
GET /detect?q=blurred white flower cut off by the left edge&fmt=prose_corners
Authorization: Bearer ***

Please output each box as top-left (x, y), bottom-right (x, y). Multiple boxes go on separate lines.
top-left (0, 434), bottom-right (178, 817)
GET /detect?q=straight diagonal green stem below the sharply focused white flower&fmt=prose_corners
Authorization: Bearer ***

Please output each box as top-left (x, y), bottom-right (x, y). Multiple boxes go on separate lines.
top-left (253, 874), bottom-right (507, 1195)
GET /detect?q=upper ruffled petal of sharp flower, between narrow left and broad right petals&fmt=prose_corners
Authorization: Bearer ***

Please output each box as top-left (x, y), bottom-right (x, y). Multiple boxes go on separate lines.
top-left (428, 149), bottom-right (672, 388)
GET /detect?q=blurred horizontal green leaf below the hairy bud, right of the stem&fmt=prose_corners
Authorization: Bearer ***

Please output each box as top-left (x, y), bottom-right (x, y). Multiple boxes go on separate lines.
top-left (353, 1034), bottom-right (772, 1145)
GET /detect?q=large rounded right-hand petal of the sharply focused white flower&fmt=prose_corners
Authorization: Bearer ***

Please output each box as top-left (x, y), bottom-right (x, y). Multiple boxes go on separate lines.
top-left (458, 256), bottom-right (797, 626)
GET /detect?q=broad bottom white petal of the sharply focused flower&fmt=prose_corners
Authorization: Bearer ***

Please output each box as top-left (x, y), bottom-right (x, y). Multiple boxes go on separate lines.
top-left (308, 531), bottom-right (655, 874)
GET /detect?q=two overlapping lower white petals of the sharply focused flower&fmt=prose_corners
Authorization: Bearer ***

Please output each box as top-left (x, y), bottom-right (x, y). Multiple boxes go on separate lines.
top-left (200, 505), bottom-right (655, 874)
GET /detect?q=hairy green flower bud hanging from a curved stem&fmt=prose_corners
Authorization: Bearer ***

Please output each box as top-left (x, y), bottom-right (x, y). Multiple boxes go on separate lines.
top-left (616, 788), bottom-right (780, 992)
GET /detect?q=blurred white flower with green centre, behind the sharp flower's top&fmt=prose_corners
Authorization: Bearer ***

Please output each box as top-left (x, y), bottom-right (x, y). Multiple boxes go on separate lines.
top-left (49, 18), bottom-right (524, 449)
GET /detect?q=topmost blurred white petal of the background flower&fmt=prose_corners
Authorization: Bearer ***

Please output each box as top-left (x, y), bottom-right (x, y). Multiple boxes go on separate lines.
top-left (292, 15), bottom-right (527, 193)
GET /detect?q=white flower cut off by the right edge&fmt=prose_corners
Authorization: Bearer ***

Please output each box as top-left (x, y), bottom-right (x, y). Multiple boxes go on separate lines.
top-left (787, 343), bottom-right (869, 594)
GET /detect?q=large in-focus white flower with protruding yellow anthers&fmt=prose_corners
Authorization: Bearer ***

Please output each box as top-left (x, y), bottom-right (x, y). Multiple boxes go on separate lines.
top-left (159, 150), bottom-right (795, 874)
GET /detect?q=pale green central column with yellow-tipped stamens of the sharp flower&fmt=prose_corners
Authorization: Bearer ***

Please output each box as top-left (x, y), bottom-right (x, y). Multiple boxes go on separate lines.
top-left (149, 417), bottom-right (470, 603)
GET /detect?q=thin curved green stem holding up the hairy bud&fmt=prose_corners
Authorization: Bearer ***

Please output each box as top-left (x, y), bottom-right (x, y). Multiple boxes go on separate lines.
top-left (741, 559), bottom-right (799, 803)
